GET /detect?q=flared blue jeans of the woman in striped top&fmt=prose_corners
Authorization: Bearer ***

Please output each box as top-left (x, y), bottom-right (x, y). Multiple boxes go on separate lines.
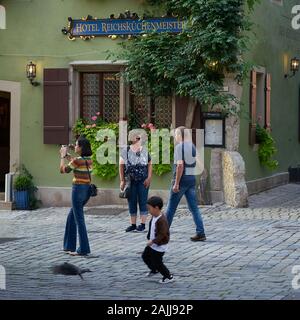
top-left (64, 184), bottom-right (91, 255)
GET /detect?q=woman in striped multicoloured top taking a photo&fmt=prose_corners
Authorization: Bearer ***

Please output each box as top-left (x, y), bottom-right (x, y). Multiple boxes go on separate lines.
top-left (60, 137), bottom-right (92, 256)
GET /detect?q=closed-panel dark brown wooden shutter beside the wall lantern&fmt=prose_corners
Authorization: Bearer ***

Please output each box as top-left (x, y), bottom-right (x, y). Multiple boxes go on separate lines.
top-left (44, 69), bottom-right (69, 144)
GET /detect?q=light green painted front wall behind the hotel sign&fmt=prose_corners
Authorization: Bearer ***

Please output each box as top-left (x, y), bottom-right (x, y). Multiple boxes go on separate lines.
top-left (0, 0), bottom-right (209, 189)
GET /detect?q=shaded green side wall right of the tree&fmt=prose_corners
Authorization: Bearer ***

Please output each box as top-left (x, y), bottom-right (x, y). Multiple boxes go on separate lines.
top-left (240, 0), bottom-right (300, 180)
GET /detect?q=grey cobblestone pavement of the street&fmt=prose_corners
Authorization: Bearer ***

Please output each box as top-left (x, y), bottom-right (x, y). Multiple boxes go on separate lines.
top-left (0, 184), bottom-right (300, 300)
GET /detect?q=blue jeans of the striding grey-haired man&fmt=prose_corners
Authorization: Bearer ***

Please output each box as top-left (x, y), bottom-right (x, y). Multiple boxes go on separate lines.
top-left (166, 181), bottom-right (205, 235)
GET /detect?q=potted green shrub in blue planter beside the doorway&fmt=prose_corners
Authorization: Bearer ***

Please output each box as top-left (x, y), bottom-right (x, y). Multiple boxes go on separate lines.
top-left (14, 166), bottom-right (38, 210)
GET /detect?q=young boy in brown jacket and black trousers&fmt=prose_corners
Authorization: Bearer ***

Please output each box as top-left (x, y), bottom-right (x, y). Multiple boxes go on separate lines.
top-left (142, 196), bottom-right (174, 283)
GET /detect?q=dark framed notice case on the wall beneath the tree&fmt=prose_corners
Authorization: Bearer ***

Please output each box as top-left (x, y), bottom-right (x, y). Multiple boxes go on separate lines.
top-left (203, 112), bottom-right (225, 148)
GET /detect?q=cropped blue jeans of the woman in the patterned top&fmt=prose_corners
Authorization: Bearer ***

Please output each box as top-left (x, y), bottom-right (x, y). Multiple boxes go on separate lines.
top-left (127, 181), bottom-right (149, 216)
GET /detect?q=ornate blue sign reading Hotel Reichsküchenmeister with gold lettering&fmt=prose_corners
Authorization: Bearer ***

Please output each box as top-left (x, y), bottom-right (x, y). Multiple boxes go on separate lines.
top-left (61, 11), bottom-right (186, 40)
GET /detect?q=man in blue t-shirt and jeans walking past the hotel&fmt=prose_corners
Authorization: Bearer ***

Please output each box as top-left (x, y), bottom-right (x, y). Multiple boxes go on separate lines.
top-left (166, 127), bottom-right (206, 241)
